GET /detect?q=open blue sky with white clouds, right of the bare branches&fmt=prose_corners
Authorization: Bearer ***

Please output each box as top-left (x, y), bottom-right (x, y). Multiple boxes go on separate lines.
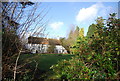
top-left (40, 2), bottom-right (118, 38)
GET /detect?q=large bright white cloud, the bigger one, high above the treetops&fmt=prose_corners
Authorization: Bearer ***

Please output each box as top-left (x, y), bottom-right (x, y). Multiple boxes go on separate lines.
top-left (76, 3), bottom-right (103, 23)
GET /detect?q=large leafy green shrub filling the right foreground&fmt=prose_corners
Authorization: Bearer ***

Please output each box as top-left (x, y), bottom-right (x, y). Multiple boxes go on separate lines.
top-left (52, 13), bottom-right (120, 80)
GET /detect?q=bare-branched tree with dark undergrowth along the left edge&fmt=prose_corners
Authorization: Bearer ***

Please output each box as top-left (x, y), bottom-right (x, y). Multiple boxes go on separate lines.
top-left (2, 2), bottom-right (47, 81)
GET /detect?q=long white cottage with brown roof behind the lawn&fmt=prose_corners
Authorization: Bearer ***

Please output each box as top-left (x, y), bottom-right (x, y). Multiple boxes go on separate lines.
top-left (26, 37), bottom-right (67, 54)
